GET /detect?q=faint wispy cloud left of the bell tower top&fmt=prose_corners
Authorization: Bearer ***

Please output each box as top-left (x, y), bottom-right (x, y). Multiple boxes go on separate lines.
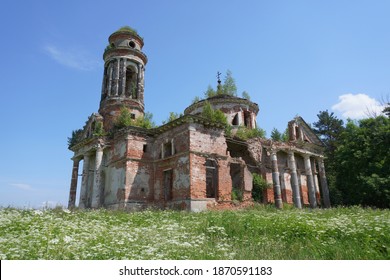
top-left (44, 45), bottom-right (100, 71)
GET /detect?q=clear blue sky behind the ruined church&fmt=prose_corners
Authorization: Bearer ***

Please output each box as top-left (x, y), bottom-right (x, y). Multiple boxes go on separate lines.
top-left (0, 0), bottom-right (390, 207)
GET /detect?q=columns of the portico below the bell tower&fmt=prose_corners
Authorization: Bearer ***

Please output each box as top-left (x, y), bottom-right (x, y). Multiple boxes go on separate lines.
top-left (68, 145), bottom-right (103, 208)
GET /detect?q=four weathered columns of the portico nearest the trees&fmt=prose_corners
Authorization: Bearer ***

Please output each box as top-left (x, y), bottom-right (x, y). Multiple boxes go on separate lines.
top-left (271, 150), bottom-right (330, 208)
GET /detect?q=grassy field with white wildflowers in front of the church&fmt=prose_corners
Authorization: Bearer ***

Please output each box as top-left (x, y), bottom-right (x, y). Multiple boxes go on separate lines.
top-left (0, 206), bottom-right (390, 260)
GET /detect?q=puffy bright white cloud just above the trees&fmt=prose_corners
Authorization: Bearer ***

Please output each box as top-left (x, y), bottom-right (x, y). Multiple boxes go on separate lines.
top-left (332, 93), bottom-right (384, 119)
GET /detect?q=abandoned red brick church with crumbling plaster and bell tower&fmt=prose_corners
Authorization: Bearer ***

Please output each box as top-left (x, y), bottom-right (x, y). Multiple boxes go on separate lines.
top-left (68, 28), bottom-right (330, 211)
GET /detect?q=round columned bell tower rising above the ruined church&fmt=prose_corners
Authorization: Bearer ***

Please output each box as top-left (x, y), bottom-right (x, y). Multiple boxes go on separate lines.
top-left (99, 26), bottom-right (147, 131)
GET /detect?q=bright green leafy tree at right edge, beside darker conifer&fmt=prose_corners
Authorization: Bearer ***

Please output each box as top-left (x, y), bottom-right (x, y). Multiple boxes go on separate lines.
top-left (335, 116), bottom-right (390, 208)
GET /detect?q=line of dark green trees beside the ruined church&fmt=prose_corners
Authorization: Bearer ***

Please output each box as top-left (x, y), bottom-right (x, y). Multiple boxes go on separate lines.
top-left (313, 106), bottom-right (390, 208)
